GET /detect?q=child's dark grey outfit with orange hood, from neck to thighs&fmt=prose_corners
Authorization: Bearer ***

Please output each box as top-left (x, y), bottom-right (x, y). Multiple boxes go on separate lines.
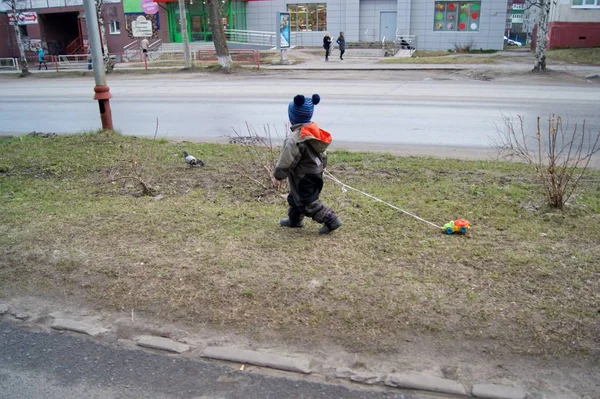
top-left (273, 122), bottom-right (331, 206)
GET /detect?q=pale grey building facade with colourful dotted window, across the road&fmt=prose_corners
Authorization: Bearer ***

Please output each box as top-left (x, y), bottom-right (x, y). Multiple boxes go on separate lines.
top-left (246, 0), bottom-right (507, 50)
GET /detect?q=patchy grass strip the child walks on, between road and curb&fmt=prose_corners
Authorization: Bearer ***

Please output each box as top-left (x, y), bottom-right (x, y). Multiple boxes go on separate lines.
top-left (0, 132), bottom-right (600, 355)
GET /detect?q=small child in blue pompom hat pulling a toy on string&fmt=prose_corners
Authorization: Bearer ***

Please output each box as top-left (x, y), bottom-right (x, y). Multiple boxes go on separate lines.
top-left (273, 94), bottom-right (342, 234)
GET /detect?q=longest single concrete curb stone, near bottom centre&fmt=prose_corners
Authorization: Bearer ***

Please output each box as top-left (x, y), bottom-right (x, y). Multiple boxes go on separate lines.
top-left (201, 346), bottom-right (311, 374)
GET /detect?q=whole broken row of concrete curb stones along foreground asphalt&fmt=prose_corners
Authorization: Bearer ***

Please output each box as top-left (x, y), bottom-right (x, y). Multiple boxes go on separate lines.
top-left (0, 303), bottom-right (527, 399)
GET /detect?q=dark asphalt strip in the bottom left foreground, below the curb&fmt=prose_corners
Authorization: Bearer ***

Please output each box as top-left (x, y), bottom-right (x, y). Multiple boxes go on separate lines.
top-left (0, 322), bottom-right (417, 399)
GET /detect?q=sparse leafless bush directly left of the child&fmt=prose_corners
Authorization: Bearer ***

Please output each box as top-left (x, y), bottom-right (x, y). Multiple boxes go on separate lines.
top-left (229, 123), bottom-right (282, 190)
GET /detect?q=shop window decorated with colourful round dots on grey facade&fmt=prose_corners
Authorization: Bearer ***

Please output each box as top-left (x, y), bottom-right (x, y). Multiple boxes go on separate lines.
top-left (433, 0), bottom-right (481, 32)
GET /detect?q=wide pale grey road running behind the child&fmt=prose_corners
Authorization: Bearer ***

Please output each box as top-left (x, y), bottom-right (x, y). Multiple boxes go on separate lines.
top-left (0, 75), bottom-right (600, 152)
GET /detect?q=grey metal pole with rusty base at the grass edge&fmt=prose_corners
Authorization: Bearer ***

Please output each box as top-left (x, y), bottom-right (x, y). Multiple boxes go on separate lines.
top-left (83, 0), bottom-right (113, 130)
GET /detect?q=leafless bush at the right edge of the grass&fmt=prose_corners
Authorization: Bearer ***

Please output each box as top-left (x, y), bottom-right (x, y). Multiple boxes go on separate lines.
top-left (494, 115), bottom-right (600, 209)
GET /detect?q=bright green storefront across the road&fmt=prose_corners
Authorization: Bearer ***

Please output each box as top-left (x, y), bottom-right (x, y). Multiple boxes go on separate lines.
top-left (123, 0), bottom-right (246, 43)
